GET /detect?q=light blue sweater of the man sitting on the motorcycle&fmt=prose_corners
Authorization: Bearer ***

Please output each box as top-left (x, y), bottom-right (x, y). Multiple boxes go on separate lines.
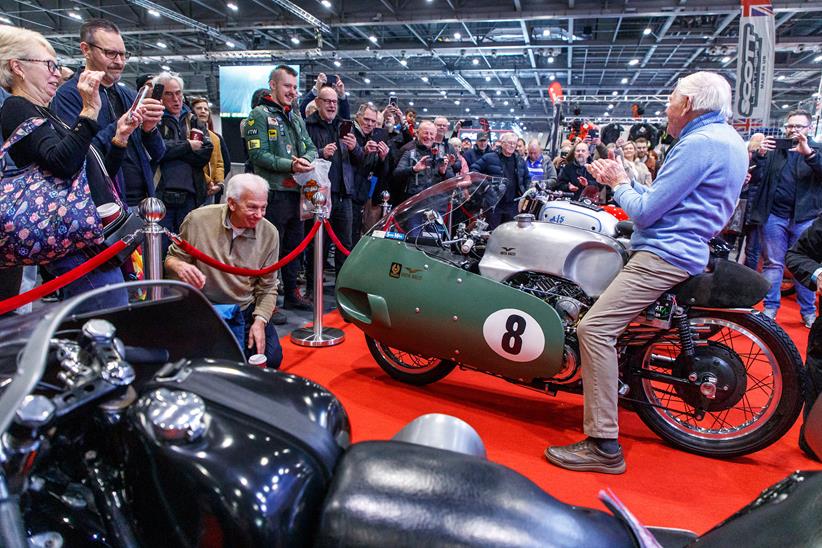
top-left (614, 112), bottom-right (748, 275)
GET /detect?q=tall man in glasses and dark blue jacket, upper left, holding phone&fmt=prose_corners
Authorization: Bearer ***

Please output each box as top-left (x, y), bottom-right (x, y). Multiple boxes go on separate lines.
top-left (51, 19), bottom-right (165, 207)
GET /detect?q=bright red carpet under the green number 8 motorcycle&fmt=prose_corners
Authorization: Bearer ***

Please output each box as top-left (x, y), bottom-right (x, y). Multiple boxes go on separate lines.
top-left (283, 300), bottom-right (822, 533)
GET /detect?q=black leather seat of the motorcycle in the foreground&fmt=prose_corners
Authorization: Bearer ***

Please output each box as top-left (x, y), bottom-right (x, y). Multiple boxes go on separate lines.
top-left (315, 441), bottom-right (634, 548)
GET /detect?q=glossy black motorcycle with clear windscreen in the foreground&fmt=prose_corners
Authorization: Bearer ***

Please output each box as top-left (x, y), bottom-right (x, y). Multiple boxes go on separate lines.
top-left (0, 282), bottom-right (822, 548)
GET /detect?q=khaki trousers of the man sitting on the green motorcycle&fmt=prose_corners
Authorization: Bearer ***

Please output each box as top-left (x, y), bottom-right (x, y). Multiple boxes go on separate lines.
top-left (577, 251), bottom-right (689, 439)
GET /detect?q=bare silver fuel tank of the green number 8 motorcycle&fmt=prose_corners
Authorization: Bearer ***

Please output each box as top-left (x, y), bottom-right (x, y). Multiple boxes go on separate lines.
top-left (479, 214), bottom-right (628, 297)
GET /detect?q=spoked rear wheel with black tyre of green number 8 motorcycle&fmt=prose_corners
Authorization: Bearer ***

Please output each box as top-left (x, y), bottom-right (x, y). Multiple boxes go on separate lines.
top-left (627, 311), bottom-right (805, 458)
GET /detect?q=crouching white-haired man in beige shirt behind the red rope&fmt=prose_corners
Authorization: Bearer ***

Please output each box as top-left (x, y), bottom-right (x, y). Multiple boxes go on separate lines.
top-left (165, 173), bottom-right (283, 368)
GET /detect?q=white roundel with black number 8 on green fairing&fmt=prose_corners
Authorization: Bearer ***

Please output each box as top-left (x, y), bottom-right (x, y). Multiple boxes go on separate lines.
top-left (482, 308), bottom-right (545, 362)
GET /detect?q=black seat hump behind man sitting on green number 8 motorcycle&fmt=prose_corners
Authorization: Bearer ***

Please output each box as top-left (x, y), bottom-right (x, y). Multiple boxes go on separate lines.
top-left (671, 259), bottom-right (770, 308)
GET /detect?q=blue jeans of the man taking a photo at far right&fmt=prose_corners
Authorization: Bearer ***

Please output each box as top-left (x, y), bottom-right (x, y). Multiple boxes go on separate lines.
top-left (761, 215), bottom-right (816, 316)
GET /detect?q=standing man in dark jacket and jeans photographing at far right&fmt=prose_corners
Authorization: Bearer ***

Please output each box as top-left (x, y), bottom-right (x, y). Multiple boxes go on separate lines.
top-left (749, 110), bottom-right (822, 329)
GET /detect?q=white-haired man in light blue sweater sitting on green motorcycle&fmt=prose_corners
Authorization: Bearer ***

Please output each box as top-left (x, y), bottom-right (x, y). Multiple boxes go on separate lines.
top-left (545, 72), bottom-right (748, 474)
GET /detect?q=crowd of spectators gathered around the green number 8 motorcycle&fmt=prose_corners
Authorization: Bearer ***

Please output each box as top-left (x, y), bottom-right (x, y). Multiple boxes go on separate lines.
top-left (0, 19), bottom-right (822, 361)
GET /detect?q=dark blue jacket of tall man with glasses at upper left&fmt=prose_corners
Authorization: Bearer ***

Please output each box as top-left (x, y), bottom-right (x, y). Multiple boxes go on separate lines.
top-left (51, 70), bottom-right (166, 203)
